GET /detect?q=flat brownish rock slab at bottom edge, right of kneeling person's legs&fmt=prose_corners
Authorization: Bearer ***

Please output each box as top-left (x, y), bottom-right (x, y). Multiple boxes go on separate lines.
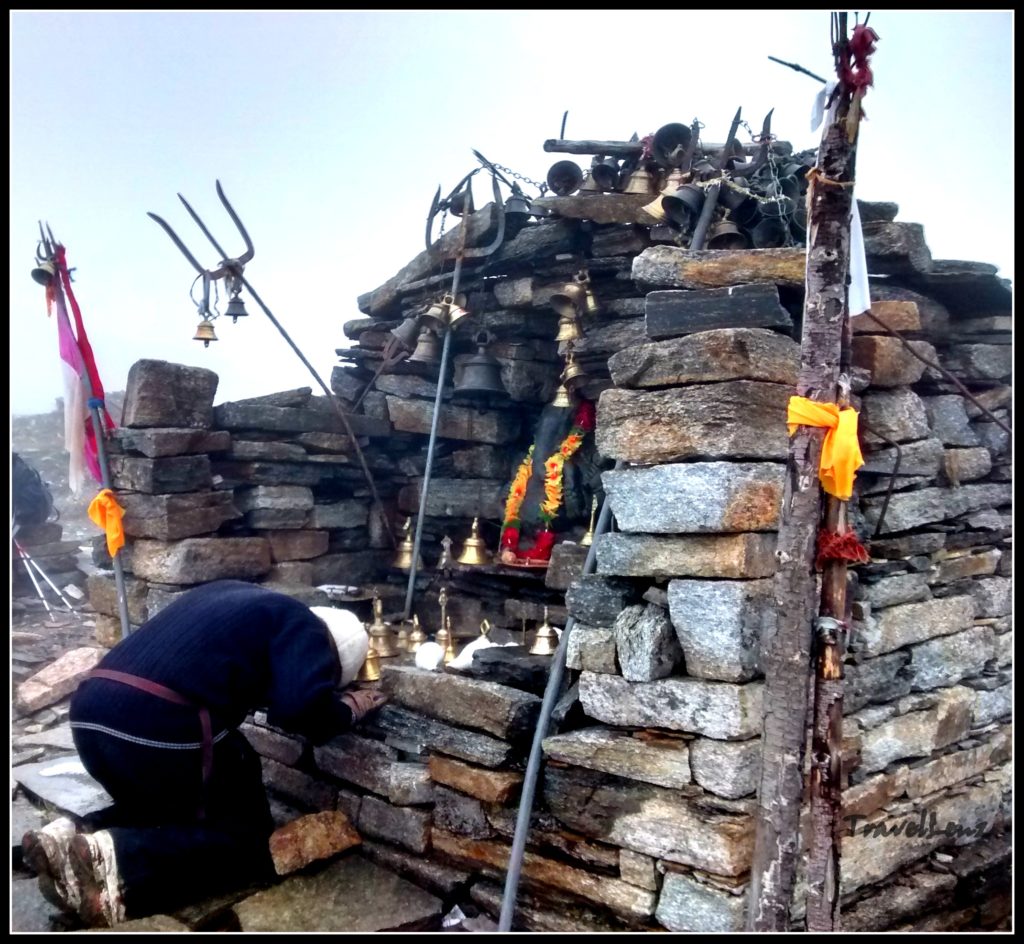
top-left (234, 855), bottom-right (441, 933)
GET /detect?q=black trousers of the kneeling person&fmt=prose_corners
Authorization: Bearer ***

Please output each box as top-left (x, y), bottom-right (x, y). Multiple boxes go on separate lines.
top-left (74, 728), bottom-right (274, 918)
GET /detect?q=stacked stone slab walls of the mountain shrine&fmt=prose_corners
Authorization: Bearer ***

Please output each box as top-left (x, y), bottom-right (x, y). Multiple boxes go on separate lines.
top-left (86, 198), bottom-right (1013, 931)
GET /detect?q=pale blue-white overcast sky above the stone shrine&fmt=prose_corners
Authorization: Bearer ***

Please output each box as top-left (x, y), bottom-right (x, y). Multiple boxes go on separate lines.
top-left (10, 9), bottom-right (1014, 414)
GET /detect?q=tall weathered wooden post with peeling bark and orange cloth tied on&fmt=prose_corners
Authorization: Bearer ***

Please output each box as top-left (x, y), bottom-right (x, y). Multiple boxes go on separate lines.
top-left (746, 13), bottom-right (877, 931)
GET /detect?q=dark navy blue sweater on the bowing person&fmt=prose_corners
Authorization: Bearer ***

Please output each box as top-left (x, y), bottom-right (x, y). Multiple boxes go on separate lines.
top-left (71, 581), bottom-right (352, 743)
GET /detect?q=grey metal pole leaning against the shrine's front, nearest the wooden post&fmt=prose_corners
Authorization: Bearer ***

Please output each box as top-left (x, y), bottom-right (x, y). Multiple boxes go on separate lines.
top-left (498, 459), bottom-right (624, 931)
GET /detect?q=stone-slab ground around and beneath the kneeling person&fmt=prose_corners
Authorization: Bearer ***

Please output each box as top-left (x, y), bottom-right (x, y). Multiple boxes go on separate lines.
top-left (10, 563), bottom-right (495, 933)
